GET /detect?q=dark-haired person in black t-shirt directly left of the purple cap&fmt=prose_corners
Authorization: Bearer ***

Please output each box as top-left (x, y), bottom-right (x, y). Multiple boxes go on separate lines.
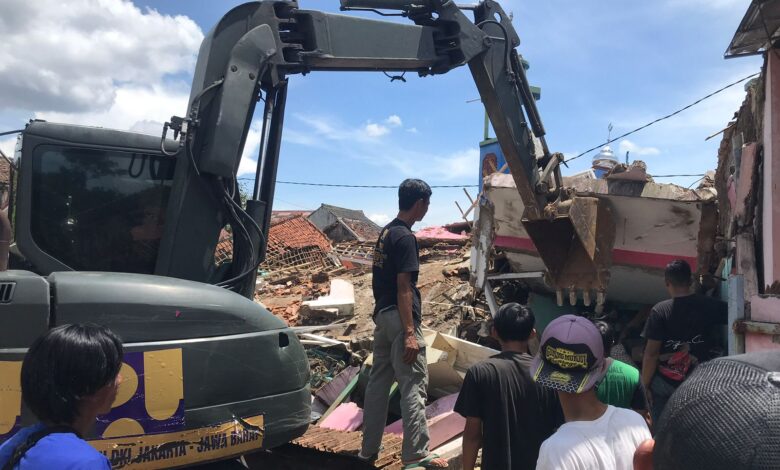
top-left (455, 303), bottom-right (563, 470)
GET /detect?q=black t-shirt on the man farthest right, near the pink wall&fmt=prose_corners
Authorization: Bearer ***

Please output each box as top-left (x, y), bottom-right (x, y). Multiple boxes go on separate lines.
top-left (643, 294), bottom-right (728, 380)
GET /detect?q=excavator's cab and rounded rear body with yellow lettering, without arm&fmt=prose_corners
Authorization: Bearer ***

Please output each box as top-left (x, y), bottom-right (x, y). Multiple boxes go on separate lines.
top-left (0, 121), bottom-right (311, 462)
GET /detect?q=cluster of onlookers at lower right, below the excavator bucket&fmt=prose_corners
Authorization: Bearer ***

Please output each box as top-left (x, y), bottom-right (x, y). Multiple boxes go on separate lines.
top-left (455, 260), bottom-right (780, 470)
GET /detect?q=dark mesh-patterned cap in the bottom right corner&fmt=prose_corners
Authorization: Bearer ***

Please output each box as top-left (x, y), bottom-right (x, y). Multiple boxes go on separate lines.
top-left (653, 351), bottom-right (780, 470)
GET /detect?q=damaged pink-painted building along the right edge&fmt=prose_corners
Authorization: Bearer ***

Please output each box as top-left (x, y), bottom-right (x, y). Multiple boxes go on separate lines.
top-left (716, 0), bottom-right (780, 354)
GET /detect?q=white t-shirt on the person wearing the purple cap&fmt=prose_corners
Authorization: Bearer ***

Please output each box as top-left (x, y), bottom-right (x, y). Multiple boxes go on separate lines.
top-left (536, 405), bottom-right (650, 470)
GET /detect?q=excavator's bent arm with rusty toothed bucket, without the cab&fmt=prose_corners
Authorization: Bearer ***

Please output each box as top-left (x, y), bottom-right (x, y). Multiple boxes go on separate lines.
top-left (171, 0), bottom-right (614, 304)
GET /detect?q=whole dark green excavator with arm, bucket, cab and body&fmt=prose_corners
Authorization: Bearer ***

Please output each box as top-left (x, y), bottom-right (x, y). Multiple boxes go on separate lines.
top-left (0, 0), bottom-right (614, 468)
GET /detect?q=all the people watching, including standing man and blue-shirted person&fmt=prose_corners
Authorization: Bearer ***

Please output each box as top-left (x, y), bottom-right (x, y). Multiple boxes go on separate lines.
top-left (0, 179), bottom-right (780, 470)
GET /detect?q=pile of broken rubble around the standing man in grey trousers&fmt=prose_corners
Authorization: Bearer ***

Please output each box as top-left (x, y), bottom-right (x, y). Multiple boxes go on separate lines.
top-left (250, 216), bottom-right (488, 468)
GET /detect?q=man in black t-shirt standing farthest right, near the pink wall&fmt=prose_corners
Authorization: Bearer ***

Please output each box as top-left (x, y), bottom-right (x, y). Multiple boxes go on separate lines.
top-left (642, 260), bottom-right (728, 423)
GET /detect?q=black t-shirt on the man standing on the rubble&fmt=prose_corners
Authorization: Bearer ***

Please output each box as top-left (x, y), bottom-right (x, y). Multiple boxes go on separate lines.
top-left (371, 219), bottom-right (422, 325)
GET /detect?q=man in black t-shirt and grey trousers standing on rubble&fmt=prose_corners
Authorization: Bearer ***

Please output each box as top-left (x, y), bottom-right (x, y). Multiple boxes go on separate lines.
top-left (358, 179), bottom-right (447, 468)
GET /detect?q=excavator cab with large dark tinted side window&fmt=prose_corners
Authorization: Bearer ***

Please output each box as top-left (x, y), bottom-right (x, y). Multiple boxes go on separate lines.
top-left (13, 122), bottom-right (177, 274)
